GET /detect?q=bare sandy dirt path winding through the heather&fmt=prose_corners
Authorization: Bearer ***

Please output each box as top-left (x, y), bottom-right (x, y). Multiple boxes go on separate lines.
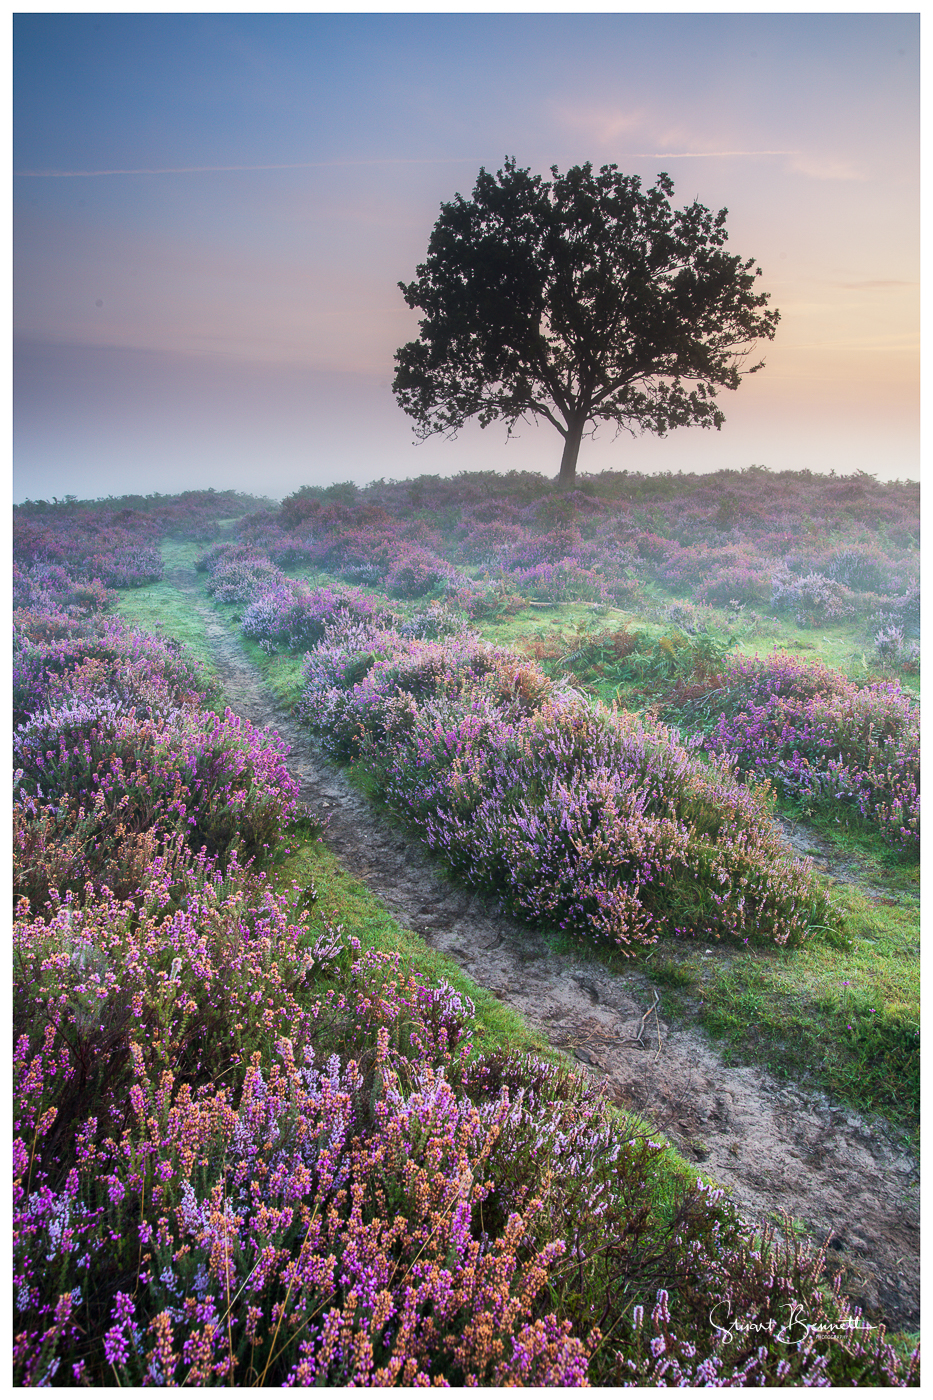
top-left (168, 570), bottom-right (919, 1330)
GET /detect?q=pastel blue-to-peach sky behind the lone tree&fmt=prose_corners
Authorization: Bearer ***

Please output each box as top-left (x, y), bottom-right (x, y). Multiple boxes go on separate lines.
top-left (14, 13), bottom-right (919, 500)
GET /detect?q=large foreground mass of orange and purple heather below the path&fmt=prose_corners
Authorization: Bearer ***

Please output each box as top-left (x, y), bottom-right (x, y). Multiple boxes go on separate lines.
top-left (14, 890), bottom-right (916, 1386)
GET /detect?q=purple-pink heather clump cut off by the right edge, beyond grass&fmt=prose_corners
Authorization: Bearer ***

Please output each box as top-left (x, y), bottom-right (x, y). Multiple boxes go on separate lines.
top-left (680, 654), bottom-right (920, 854)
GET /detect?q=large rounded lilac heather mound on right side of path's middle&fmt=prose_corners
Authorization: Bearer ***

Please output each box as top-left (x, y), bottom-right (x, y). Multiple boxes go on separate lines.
top-left (382, 697), bottom-right (831, 948)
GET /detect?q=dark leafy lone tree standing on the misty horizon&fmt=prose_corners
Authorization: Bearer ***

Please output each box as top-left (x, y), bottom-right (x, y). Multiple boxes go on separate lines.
top-left (392, 158), bottom-right (779, 483)
